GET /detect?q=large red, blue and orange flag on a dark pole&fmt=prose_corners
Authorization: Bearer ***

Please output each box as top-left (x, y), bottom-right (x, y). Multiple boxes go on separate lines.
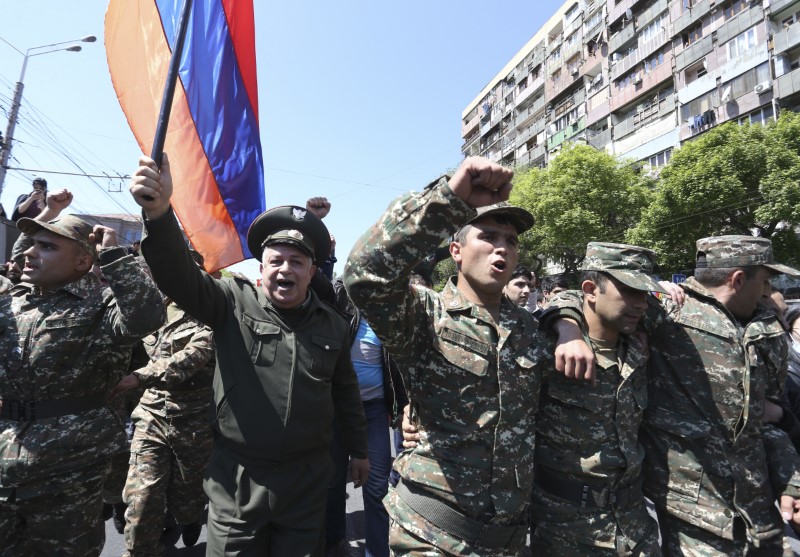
top-left (105, 0), bottom-right (265, 271)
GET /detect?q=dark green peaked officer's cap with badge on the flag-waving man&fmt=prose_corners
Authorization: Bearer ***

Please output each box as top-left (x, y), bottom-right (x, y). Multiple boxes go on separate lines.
top-left (247, 205), bottom-right (331, 263)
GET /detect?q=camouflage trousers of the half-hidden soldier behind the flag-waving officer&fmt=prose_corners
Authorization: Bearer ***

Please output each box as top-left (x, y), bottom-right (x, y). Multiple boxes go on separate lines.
top-left (122, 407), bottom-right (213, 557)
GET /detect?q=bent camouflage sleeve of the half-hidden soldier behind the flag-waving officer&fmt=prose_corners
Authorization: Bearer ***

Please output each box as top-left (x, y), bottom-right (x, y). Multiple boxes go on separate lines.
top-left (136, 324), bottom-right (214, 389)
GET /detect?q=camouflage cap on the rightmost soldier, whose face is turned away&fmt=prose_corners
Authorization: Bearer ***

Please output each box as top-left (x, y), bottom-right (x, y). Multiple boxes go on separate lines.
top-left (695, 235), bottom-right (800, 277)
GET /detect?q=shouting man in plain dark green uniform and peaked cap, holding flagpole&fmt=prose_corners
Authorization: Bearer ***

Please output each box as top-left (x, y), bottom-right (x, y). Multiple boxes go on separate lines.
top-left (130, 156), bottom-right (369, 557)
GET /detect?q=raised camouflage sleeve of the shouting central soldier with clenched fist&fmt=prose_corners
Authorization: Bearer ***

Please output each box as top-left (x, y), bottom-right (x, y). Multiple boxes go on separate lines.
top-left (344, 178), bottom-right (476, 354)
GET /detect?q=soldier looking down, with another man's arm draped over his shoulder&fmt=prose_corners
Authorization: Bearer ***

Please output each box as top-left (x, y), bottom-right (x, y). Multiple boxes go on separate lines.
top-left (531, 242), bottom-right (662, 557)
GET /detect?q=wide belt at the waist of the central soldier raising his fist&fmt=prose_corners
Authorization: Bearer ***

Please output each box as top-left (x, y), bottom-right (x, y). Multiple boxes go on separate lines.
top-left (395, 480), bottom-right (528, 548)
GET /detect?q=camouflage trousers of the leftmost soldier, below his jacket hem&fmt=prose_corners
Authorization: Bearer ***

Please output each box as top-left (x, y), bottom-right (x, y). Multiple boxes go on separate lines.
top-left (0, 459), bottom-right (108, 557)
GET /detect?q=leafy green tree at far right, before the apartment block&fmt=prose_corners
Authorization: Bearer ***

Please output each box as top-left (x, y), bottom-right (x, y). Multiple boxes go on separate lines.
top-left (627, 111), bottom-right (800, 270)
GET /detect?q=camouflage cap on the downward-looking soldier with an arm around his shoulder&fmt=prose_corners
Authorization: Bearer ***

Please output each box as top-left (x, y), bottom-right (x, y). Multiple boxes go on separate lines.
top-left (580, 242), bottom-right (667, 293)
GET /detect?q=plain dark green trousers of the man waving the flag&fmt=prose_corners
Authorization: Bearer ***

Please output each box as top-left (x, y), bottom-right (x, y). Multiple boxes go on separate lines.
top-left (203, 447), bottom-right (331, 557)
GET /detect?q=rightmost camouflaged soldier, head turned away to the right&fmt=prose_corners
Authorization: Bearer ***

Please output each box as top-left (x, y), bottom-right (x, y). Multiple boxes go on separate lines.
top-left (557, 236), bottom-right (800, 556)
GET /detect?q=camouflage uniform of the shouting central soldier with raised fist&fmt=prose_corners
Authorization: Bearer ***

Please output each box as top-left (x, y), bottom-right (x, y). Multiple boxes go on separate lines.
top-left (344, 179), bottom-right (546, 556)
